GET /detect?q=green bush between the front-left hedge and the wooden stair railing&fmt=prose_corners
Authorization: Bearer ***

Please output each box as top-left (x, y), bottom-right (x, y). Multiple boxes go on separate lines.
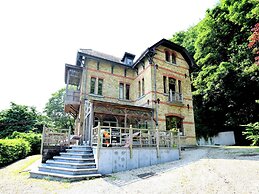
top-left (9, 131), bottom-right (41, 154)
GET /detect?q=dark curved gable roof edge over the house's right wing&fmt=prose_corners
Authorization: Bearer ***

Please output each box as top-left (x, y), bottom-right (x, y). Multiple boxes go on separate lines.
top-left (133, 39), bottom-right (196, 69)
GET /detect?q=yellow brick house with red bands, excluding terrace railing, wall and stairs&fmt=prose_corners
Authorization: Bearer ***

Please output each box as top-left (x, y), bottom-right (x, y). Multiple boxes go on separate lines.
top-left (65, 39), bottom-right (196, 146)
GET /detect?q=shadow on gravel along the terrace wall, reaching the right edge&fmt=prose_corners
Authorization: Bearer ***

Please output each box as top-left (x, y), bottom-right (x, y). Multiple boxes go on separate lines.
top-left (104, 146), bottom-right (259, 187)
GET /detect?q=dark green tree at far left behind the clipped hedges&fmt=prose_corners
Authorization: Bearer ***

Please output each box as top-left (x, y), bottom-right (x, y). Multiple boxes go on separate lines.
top-left (0, 102), bottom-right (42, 138)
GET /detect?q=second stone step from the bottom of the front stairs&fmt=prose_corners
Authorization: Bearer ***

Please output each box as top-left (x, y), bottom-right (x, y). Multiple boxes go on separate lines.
top-left (39, 166), bottom-right (98, 175)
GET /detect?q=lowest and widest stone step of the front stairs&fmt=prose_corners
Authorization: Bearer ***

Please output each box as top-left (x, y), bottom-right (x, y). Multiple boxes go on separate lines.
top-left (30, 170), bottom-right (102, 181)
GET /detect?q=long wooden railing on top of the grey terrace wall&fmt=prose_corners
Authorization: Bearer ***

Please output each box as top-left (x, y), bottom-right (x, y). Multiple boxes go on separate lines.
top-left (92, 123), bottom-right (180, 147)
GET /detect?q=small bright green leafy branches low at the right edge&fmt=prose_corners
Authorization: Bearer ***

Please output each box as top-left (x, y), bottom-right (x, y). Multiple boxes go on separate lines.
top-left (243, 122), bottom-right (259, 146)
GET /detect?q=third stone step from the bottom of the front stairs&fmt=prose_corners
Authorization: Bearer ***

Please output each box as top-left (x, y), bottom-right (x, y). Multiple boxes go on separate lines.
top-left (46, 160), bottom-right (96, 169)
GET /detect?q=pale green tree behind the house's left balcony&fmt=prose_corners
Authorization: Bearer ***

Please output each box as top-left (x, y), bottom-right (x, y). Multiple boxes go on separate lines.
top-left (44, 88), bottom-right (74, 129)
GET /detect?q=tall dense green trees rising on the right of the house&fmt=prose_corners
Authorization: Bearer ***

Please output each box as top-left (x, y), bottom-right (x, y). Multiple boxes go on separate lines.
top-left (171, 0), bottom-right (259, 142)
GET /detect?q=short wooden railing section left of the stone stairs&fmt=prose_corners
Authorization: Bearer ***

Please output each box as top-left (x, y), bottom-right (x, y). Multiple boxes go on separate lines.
top-left (41, 127), bottom-right (71, 153)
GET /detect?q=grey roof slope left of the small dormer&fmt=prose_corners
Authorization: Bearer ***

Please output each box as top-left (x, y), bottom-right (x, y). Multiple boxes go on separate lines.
top-left (79, 49), bottom-right (125, 65)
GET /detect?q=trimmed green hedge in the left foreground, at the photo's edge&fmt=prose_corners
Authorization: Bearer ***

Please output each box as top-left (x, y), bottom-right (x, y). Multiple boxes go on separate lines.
top-left (0, 139), bottom-right (30, 167)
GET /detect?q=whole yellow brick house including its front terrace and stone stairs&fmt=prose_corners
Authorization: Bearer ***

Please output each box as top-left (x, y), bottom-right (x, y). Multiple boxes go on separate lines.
top-left (31, 39), bottom-right (196, 180)
